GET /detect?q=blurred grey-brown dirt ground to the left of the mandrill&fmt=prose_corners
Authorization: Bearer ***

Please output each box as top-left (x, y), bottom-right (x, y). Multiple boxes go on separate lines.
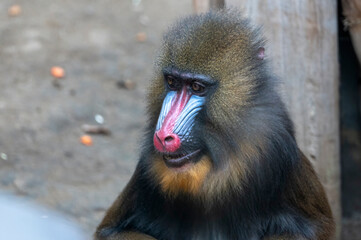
top-left (0, 0), bottom-right (361, 240)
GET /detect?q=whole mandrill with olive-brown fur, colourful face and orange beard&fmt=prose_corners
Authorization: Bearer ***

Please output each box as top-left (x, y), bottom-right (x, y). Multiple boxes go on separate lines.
top-left (95, 11), bottom-right (334, 240)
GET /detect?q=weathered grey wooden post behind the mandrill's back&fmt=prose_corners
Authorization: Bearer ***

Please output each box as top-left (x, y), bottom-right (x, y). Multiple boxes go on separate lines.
top-left (191, 0), bottom-right (341, 239)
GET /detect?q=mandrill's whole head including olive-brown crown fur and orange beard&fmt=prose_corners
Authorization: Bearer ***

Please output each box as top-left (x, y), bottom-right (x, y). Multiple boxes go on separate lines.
top-left (147, 11), bottom-right (264, 196)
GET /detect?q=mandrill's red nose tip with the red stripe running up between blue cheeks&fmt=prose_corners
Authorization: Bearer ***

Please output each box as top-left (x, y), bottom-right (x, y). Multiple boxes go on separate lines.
top-left (153, 87), bottom-right (190, 152)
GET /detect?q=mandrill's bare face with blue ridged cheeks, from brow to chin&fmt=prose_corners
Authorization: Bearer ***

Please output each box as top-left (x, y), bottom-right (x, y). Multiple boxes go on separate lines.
top-left (153, 67), bottom-right (216, 170)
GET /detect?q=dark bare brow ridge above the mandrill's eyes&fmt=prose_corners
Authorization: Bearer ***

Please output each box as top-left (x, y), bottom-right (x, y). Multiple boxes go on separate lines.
top-left (163, 67), bottom-right (217, 86)
